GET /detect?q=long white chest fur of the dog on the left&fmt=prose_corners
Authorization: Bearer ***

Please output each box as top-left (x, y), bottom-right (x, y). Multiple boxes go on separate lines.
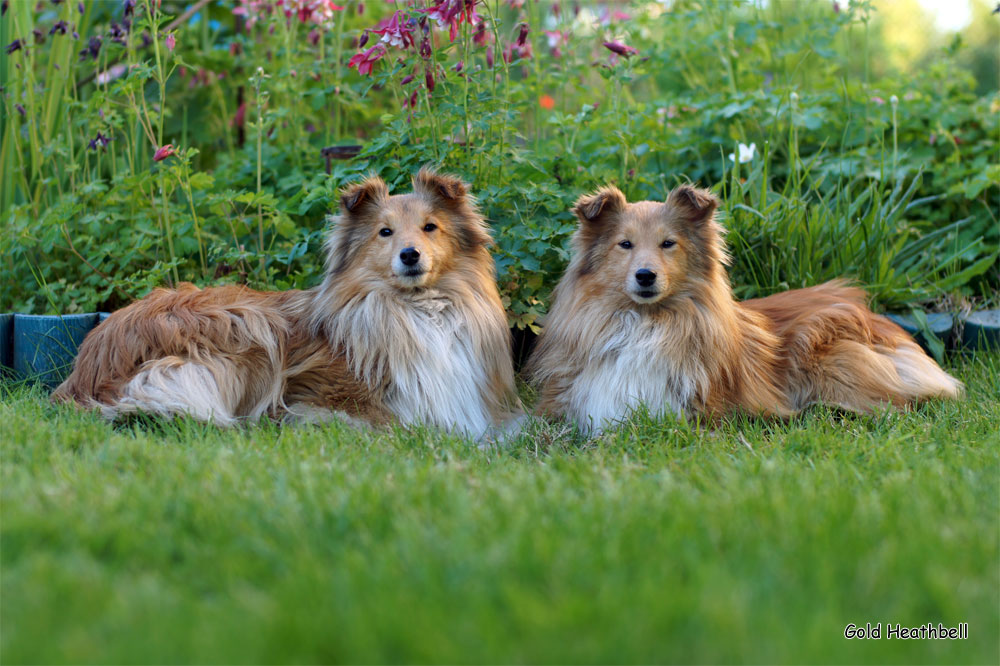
top-left (386, 297), bottom-right (492, 437)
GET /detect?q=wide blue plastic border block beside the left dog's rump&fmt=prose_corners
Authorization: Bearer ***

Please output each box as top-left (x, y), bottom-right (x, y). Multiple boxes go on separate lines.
top-left (14, 313), bottom-right (97, 388)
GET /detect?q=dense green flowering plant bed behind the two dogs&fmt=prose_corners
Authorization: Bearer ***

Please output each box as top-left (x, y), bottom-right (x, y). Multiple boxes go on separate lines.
top-left (0, 0), bottom-right (1000, 327)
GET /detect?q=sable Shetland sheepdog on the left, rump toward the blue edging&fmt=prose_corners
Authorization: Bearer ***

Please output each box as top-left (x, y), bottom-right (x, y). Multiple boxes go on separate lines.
top-left (53, 169), bottom-right (520, 437)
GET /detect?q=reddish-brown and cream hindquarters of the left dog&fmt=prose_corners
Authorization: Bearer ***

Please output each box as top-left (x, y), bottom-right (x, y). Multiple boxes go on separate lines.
top-left (52, 284), bottom-right (287, 425)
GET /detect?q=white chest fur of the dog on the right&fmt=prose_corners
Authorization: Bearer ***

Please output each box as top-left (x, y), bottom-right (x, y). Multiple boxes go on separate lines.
top-left (563, 312), bottom-right (705, 433)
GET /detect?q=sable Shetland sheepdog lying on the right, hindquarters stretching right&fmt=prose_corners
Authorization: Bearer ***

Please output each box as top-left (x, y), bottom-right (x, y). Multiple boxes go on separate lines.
top-left (529, 185), bottom-right (962, 431)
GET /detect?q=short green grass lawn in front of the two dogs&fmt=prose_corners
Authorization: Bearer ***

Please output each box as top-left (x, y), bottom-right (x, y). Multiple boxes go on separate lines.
top-left (0, 355), bottom-right (1000, 664)
